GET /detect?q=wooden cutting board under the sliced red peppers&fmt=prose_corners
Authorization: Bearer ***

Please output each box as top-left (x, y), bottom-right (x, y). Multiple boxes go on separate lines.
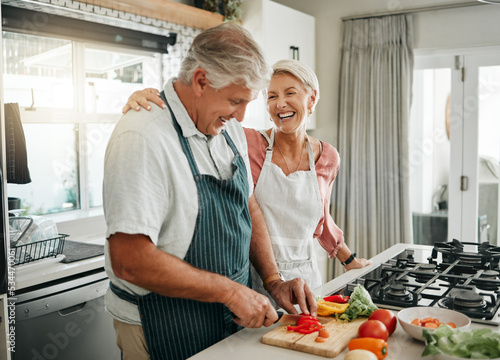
top-left (262, 318), bottom-right (368, 358)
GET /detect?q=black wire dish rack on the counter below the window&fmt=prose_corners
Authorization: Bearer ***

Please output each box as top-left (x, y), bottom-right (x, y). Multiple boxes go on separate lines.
top-left (9, 234), bottom-right (69, 266)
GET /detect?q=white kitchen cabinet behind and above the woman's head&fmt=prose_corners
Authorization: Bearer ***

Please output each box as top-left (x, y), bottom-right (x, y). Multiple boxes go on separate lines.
top-left (241, 0), bottom-right (316, 129)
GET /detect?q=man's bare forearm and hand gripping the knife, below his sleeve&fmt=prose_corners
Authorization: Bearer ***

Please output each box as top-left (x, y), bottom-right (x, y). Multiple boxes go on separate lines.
top-left (108, 233), bottom-right (278, 328)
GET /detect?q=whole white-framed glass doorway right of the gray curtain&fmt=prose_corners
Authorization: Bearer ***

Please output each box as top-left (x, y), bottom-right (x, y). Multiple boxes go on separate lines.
top-left (410, 48), bottom-right (500, 245)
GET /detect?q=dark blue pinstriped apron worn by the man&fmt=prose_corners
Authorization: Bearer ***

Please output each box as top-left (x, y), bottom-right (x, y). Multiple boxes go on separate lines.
top-left (110, 92), bottom-right (252, 360)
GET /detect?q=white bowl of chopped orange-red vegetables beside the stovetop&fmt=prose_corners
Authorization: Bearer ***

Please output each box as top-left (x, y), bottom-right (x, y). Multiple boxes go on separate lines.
top-left (398, 306), bottom-right (470, 341)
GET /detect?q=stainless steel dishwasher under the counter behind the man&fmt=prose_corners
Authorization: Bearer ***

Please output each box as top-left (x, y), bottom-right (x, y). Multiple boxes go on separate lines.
top-left (12, 268), bottom-right (121, 360)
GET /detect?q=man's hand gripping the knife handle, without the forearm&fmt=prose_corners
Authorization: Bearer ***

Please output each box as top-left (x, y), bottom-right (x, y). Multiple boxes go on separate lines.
top-left (224, 284), bottom-right (278, 328)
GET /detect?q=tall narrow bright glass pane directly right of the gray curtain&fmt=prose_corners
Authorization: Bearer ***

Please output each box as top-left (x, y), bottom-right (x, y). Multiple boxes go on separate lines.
top-left (409, 63), bottom-right (451, 245)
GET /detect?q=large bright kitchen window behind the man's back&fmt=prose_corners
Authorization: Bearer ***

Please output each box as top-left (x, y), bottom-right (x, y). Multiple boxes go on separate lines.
top-left (2, 32), bottom-right (163, 214)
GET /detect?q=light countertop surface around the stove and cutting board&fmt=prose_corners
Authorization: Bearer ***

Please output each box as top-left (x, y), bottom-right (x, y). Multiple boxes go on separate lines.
top-left (190, 244), bottom-right (499, 360)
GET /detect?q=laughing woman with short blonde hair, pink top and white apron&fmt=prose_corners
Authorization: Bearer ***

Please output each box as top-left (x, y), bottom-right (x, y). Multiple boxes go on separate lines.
top-left (123, 60), bottom-right (370, 300)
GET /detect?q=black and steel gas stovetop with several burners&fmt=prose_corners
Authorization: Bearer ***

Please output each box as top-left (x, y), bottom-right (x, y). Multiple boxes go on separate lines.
top-left (337, 240), bottom-right (500, 326)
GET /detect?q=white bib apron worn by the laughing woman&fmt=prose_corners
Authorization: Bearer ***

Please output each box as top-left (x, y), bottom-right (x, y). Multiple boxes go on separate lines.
top-left (252, 129), bottom-right (323, 304)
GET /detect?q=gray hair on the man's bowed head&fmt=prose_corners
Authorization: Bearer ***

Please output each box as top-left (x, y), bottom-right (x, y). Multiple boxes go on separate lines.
top-left (179, 23), bottom-right (271, 91)
